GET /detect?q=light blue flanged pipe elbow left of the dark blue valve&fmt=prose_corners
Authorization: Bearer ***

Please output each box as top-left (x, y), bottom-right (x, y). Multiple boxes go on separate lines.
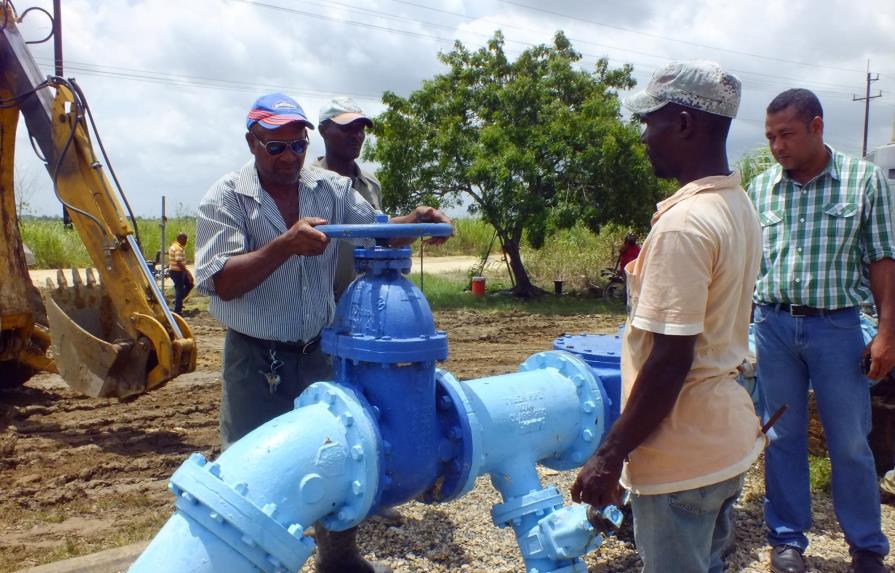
top-left (130, 382), bottom-right (379, 573)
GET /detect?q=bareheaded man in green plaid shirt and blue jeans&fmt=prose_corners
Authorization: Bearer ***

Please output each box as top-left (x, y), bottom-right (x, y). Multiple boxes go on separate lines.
top-left (749, 89), bottom-right (895, 573)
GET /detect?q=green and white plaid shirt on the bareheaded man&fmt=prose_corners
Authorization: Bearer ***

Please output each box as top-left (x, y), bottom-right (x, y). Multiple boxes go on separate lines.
top-left (749, 147), bottom-right (895, 310)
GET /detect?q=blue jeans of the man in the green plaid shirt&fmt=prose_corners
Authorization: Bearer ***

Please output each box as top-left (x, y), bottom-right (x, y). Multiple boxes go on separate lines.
top-left (754, 305), bottom-right (889, 555)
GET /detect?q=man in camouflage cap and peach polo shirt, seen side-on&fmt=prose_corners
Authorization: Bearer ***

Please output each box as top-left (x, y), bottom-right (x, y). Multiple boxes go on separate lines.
top-left (572, 61), bottom-right (765, 573)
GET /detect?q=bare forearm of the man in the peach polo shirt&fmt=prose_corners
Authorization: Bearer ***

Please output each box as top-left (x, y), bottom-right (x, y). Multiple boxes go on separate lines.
top-left (597, 335), bottom-right (696, 459)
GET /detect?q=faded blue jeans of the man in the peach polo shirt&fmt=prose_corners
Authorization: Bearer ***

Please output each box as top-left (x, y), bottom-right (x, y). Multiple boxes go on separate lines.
top-left (631, 474), bottom-right (743, 573)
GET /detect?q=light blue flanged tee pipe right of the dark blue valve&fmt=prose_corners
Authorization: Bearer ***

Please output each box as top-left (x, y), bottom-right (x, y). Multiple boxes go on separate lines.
top-left (437, 352), bottom-right (621, 573)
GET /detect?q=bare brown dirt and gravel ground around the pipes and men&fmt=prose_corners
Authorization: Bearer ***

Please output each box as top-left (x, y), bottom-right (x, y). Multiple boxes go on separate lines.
top-left (0, 311), bottom-right (895, 573)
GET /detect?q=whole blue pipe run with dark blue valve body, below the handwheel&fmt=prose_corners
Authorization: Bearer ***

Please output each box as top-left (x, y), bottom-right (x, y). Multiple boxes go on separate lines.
top-left (131, 221), bottom-right (620, 573)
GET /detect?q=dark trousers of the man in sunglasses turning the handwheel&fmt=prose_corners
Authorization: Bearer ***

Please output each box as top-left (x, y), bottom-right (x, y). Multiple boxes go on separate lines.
top-left (220, 329), bottom-right (333, 450)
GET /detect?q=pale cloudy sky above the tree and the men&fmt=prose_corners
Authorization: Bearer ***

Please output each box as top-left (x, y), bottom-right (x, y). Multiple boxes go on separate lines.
top-left (8, 0), bottom-right (895, 217)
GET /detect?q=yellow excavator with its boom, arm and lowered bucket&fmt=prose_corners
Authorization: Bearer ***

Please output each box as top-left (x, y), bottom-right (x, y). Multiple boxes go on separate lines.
top-left (0, 1), bottom-right (196, 399)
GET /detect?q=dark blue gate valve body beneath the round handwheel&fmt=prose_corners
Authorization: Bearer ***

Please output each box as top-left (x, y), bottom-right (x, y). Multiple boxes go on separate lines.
top-left (322, 239), bottom-right (448, 506)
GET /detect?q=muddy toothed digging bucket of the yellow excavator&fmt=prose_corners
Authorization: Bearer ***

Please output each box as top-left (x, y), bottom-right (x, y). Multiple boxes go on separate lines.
top-left (47, 282), bottom-right (152, 398)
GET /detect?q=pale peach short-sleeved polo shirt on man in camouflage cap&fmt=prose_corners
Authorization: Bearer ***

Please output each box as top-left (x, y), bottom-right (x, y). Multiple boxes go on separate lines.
top-left (622, 172), bottom-right (765, 495)
